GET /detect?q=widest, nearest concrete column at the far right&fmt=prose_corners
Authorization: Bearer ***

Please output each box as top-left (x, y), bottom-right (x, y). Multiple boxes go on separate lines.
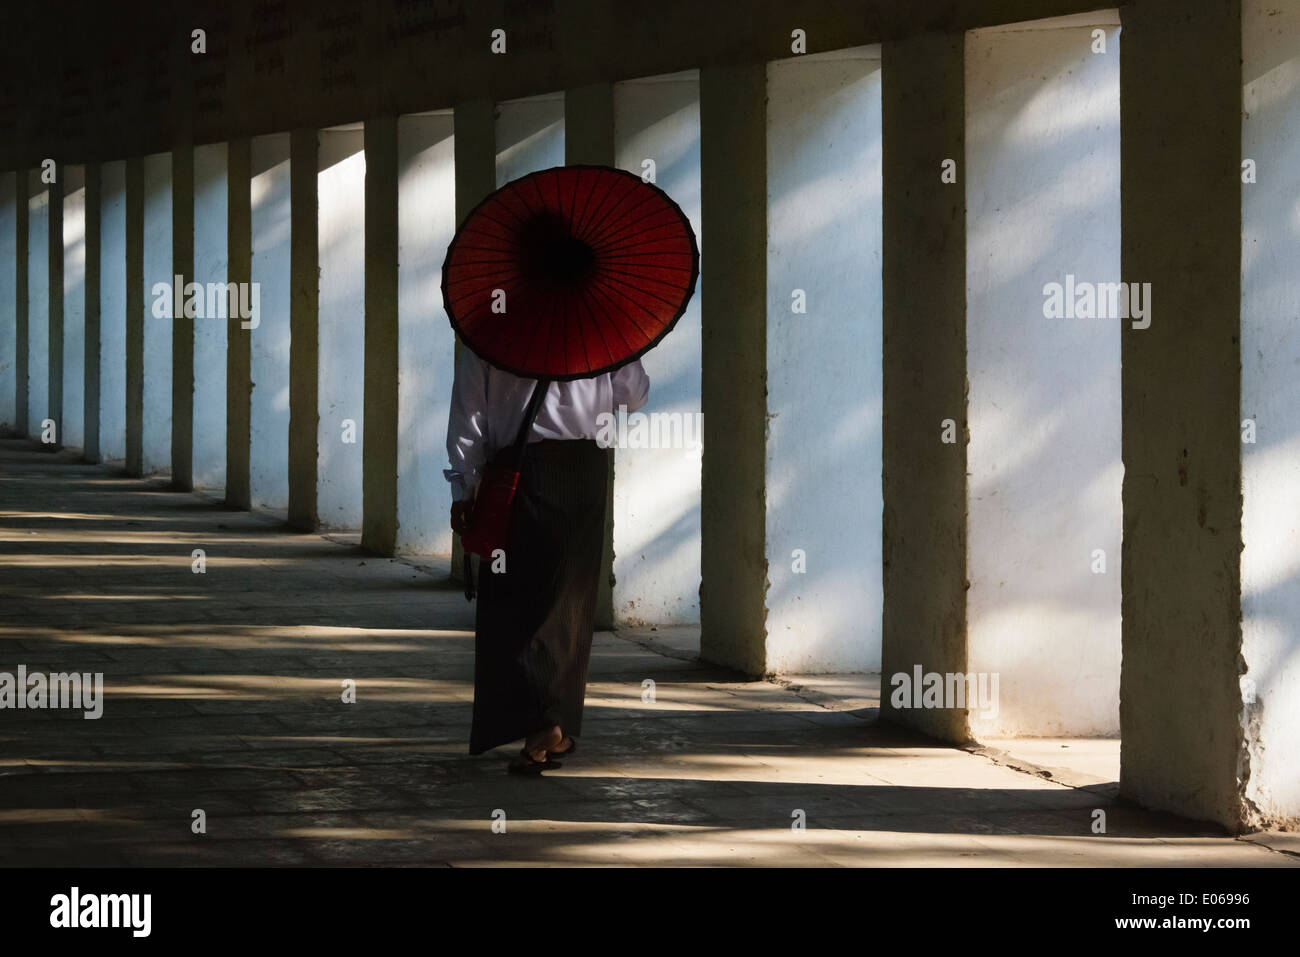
top-left (1119, 0), bottom-right (1245, 828)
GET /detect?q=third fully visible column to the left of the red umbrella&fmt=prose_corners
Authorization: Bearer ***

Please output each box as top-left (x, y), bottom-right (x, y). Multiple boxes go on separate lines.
top-left (226, 137), bottom-right (252, 508)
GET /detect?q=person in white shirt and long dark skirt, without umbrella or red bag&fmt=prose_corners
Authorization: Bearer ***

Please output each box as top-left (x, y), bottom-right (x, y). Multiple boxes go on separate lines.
top-left (445, 348), bottom-right (650, 774)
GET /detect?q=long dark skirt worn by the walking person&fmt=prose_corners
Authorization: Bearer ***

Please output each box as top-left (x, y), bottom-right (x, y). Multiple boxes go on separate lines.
top-left (469, 439), bottom-right (610, 754)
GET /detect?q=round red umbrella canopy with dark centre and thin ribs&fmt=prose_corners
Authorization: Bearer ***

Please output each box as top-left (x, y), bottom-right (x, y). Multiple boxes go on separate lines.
top-left (442, 166), bottom-right (699, 380)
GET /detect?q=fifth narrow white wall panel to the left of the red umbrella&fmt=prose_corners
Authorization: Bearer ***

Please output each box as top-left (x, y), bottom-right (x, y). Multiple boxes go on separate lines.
top-left (143, 153), bottom-right (173, 475)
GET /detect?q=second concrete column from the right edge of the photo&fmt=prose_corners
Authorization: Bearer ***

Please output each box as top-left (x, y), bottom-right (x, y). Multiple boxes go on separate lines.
top-left (878, 34), bottom-right (969, 741)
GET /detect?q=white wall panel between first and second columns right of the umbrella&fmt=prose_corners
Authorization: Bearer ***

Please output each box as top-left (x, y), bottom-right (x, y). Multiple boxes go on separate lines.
top-left (759, 47), bottom-right (883, 672)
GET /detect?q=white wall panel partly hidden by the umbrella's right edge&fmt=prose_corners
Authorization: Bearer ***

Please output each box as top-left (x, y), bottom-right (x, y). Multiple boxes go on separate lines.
top-left (614, 70), bottom-right (703, 625)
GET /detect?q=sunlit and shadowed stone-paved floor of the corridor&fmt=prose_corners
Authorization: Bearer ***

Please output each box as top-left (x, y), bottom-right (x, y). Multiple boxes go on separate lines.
top-left (0, 439), bottom-right (1300, 866)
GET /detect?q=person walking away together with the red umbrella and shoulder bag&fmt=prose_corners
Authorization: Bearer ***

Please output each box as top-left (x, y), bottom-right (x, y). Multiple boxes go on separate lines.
top-left (442, 165), bottom-right (699, 774)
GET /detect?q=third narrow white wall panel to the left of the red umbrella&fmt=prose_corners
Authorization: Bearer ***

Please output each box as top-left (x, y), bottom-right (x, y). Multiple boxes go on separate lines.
top-left (248, 133), bottom-right (290, 508)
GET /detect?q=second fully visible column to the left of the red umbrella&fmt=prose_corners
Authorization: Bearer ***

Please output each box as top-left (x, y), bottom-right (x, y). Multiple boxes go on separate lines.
top-left (289, 129), bottom-right (320, 532)
